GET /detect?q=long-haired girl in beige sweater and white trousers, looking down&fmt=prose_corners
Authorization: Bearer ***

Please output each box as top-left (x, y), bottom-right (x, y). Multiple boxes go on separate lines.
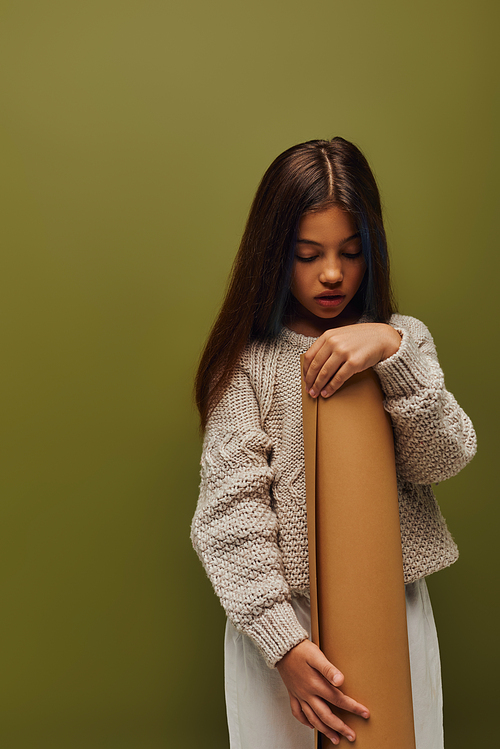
top-left (192, 138), bottom-right (475, 749)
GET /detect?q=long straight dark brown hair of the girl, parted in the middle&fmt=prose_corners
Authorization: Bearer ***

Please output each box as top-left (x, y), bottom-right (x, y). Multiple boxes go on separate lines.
top-left (195, 138), bottom-right (395, 428)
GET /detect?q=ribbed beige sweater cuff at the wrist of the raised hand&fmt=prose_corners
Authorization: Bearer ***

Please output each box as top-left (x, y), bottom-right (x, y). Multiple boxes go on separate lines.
top-left (373, 328), bottom-right (436, 398)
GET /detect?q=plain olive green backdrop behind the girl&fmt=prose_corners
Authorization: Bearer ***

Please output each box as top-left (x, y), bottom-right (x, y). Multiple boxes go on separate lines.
top-left (0, 0), bottom-right (500, 749)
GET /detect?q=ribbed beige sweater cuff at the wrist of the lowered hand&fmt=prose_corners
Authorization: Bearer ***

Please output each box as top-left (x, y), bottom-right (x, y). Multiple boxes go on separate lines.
top-left (246, 601), bottom-right (309, 667)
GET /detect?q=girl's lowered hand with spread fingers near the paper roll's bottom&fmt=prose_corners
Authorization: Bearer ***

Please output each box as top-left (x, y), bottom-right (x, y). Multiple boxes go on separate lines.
top-left (276, 640), bottom-right (370, 744)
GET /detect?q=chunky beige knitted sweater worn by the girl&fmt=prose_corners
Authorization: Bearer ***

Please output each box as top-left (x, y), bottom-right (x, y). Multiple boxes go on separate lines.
top-left (191, 315), bottom-right (476, 666)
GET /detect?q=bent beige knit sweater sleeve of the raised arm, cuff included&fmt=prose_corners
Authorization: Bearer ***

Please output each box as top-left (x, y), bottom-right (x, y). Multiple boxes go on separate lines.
top-left (374, 315), bottom-right (476, 484)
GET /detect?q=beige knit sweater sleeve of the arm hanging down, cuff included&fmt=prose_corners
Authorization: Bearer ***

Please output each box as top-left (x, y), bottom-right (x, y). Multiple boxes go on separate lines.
top-left (191, 356), bottom-right (308, 666)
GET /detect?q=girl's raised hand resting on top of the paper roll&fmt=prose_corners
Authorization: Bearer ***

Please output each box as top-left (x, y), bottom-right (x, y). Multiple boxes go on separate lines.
top-left (304, 323), bottom-right (401, 398)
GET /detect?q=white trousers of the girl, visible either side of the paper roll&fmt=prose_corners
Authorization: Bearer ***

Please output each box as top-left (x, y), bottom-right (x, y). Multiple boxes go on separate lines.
top-left (225, 579), bottom-right (444, 749)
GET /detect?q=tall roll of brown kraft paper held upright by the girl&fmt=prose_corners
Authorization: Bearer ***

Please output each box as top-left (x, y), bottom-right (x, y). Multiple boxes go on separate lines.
top-left (302, 360), bottom-right (415, 749)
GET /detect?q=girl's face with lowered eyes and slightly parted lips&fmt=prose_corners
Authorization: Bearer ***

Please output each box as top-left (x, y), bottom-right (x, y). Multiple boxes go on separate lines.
top-left (290, 205), bottom-right (366, 335)
